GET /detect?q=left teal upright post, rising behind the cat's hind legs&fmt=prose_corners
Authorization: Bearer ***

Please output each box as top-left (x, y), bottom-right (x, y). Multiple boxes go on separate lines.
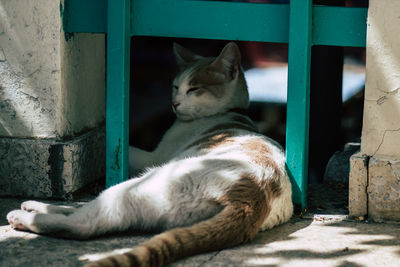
top-left (106, 0), bottom-right (130, 187)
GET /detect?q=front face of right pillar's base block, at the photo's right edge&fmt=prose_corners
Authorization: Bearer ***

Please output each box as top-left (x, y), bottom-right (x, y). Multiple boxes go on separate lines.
top-left (368, 157), bottom-right (400, 221)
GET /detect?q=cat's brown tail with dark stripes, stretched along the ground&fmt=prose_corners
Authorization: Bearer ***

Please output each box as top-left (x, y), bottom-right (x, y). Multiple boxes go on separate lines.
top-left (88, 176), bottom-right (279, 267)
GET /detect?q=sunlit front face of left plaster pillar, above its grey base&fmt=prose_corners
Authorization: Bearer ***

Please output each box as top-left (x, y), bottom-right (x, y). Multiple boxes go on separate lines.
top-left (0, 0), bottom-right (61, 137)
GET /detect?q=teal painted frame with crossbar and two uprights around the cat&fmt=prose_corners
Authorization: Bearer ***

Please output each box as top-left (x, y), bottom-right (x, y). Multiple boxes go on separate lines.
top-left (63, 0), bottom-right (367, 208)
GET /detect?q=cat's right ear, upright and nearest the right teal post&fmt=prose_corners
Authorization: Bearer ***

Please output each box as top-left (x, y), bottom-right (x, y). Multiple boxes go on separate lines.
top-left (210, 42), bottom-right (240, 81)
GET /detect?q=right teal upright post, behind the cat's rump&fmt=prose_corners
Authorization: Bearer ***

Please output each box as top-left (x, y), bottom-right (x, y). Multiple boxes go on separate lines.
top-left (286, 0), bottom-right (312, 209)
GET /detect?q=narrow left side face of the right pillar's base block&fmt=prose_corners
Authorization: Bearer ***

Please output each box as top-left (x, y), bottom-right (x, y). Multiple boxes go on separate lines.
top-left (349, 153), bottom-right (368, 217)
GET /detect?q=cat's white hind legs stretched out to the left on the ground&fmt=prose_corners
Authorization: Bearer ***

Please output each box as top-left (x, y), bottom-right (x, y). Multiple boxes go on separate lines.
top-left (7, 178), bottom-right (145, 239)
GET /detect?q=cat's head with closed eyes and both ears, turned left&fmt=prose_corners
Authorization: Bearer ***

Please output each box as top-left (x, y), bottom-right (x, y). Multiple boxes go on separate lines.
top-left (172, 42), bottom-right (249, 121)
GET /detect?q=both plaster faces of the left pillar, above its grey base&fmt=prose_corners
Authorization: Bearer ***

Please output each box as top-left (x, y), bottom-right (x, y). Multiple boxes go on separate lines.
top-left (0, 0), bottom-right (105, 139)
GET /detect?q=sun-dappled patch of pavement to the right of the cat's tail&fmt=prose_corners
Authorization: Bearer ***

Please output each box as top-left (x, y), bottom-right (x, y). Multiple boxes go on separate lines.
top-left (174, 217), bottom-right (400, 267)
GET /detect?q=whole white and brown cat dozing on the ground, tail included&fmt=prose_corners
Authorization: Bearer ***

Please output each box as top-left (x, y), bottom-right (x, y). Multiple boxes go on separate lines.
top-left (7, 43), bottom-right (293, 266)
